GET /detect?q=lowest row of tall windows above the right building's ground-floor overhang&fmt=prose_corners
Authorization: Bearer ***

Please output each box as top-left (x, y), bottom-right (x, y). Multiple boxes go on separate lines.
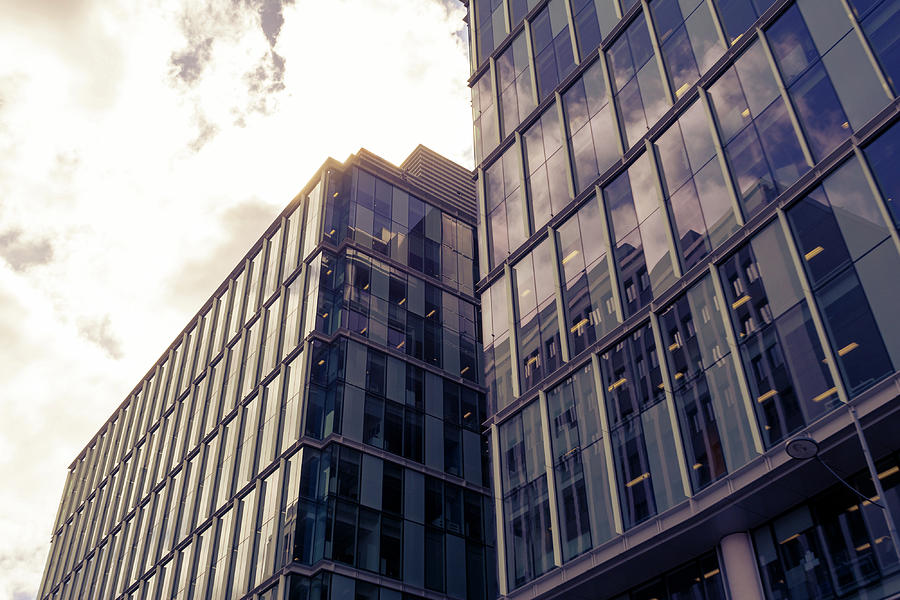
top-left (485, 138), bottom-right (900, 586)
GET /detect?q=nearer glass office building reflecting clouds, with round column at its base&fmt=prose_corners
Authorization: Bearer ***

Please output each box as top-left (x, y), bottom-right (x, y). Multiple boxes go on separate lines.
top-left (467, 0), bottom-right (900, 600)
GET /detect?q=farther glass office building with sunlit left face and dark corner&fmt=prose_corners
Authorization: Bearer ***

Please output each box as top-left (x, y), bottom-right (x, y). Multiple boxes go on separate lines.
top-left (39, 146), bottom-right (497, 600)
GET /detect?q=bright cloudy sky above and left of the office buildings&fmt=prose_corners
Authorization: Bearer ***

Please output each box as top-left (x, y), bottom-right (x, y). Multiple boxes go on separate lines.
top-left (0, 0), bottom-right (473, 600)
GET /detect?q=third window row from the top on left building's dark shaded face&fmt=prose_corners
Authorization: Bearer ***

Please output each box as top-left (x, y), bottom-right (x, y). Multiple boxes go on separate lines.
top-left (305, 339), bottom-right (488, 487)
